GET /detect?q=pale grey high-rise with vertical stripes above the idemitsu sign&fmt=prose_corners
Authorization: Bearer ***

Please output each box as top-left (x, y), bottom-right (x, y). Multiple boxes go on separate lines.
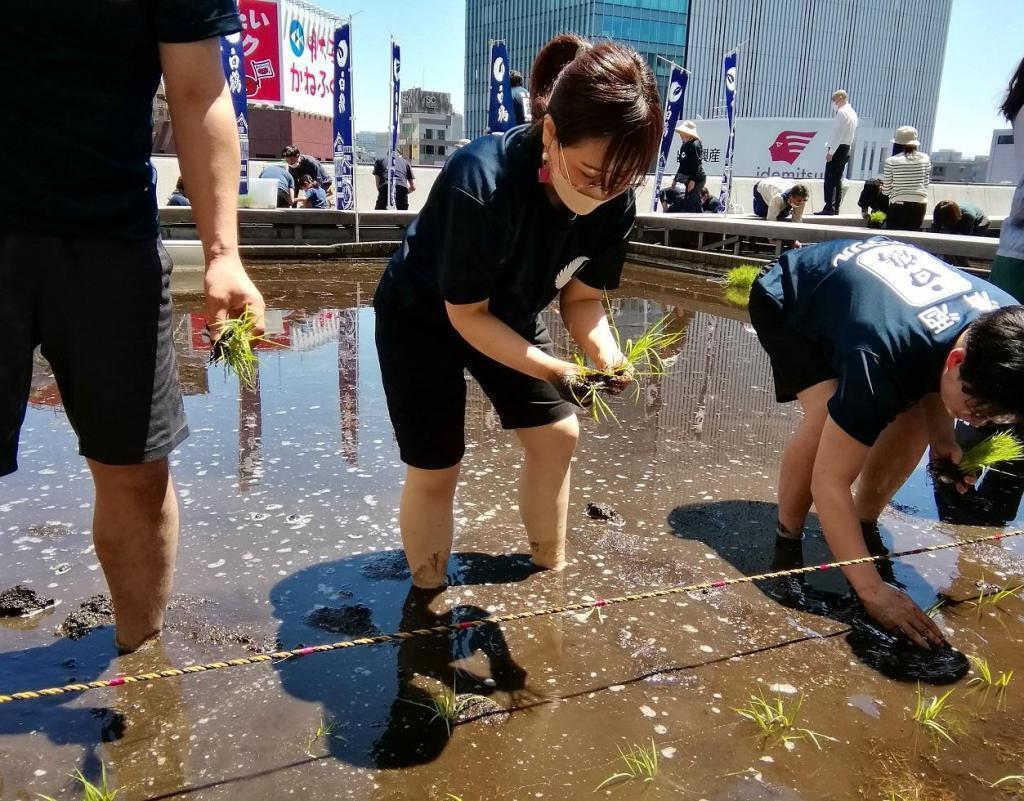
top-left (684, 0), bottom-right (952, 152)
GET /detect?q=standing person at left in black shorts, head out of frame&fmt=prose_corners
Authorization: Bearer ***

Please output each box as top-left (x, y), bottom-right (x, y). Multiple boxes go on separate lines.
top-left (0, 0), bottom-right (263, 650)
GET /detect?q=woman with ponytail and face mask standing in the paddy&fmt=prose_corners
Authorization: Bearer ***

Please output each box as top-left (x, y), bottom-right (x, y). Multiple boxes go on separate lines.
top-left (374, 35), bottom-right (662, 588)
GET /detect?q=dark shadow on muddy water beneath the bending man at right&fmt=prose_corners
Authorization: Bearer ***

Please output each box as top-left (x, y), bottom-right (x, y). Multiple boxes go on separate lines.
top-left (668, 500), bottom-right (969, 684)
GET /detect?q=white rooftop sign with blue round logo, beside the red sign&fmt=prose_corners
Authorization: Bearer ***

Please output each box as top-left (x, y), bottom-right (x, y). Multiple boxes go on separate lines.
top-left (281, 0), bottom-right (340, 117)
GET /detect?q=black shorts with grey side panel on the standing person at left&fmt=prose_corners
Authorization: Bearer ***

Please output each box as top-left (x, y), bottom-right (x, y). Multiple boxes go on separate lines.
top-left (0, 233), bottom-right (188, 475)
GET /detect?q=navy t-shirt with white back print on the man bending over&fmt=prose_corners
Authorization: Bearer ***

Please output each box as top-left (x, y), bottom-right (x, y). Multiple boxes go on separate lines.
top-left (758, 237), bottom-right (1017, 446)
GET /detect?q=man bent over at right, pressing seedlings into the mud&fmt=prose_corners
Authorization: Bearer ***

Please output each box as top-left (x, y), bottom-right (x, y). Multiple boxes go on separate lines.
top-left (750, 238), bottom-right (1024, 646)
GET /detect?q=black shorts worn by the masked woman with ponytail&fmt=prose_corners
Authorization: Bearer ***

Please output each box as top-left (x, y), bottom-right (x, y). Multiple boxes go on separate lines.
top-left (374, 284), bottom-right (575, 470)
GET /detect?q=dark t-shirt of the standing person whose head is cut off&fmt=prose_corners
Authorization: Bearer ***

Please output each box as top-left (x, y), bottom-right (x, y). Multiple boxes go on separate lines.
top-left (0, 0), bottom-right (241, 239)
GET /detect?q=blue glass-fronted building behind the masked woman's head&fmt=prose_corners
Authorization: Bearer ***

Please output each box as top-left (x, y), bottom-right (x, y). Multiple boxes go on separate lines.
top-left (466, 0), bottom-right (690, 138)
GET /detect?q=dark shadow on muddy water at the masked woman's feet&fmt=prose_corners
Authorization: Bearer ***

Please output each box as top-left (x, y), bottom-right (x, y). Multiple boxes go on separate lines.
top-left (270, 550), bottom-right (540, 769)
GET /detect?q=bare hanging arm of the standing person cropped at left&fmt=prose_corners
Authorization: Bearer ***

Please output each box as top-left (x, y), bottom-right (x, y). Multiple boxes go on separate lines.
top-left (160, 38), bottom-right (264, 336)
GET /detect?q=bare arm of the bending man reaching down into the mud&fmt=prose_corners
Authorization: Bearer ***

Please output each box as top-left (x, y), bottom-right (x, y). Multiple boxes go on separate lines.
top-left (811, 415), bottom-right (944, 647)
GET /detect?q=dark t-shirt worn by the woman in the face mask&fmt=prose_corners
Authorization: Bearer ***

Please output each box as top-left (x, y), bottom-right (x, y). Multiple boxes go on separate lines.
top-left (382, 126), bottom-right (636, 333)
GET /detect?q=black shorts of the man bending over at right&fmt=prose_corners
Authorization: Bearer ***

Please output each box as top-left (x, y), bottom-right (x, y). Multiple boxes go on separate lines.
top-left (748, 281), bottom-right (838, 404)
